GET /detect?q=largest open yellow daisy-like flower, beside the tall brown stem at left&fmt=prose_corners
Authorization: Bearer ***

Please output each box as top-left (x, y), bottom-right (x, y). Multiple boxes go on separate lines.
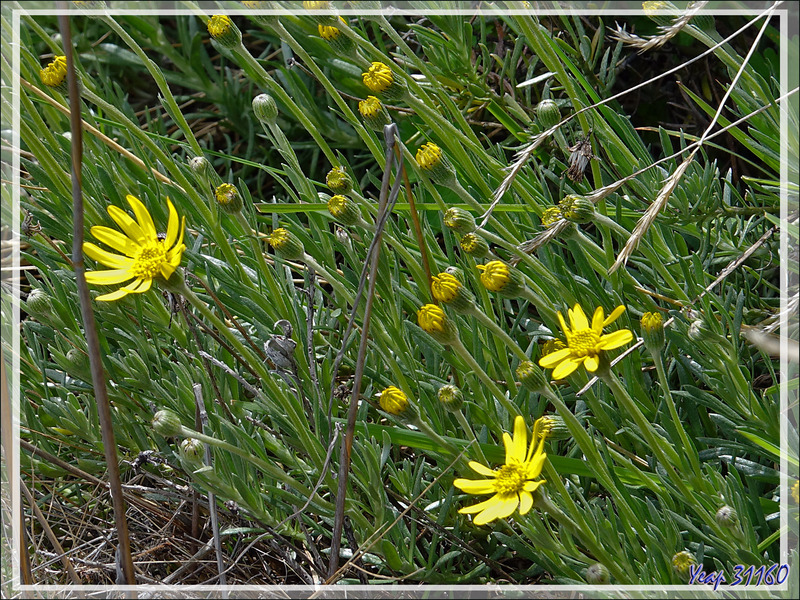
top-left (83, 195), bottom-right (186, 302)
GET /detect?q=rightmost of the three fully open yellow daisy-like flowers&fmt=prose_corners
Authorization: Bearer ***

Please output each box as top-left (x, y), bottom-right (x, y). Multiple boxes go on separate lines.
top-left (539, 304), bottom-right (633, 379)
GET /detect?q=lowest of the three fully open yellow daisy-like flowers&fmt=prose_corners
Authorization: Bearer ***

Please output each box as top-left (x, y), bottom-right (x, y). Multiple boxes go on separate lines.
top-left (453, 416), bottom-right (547, 525)
